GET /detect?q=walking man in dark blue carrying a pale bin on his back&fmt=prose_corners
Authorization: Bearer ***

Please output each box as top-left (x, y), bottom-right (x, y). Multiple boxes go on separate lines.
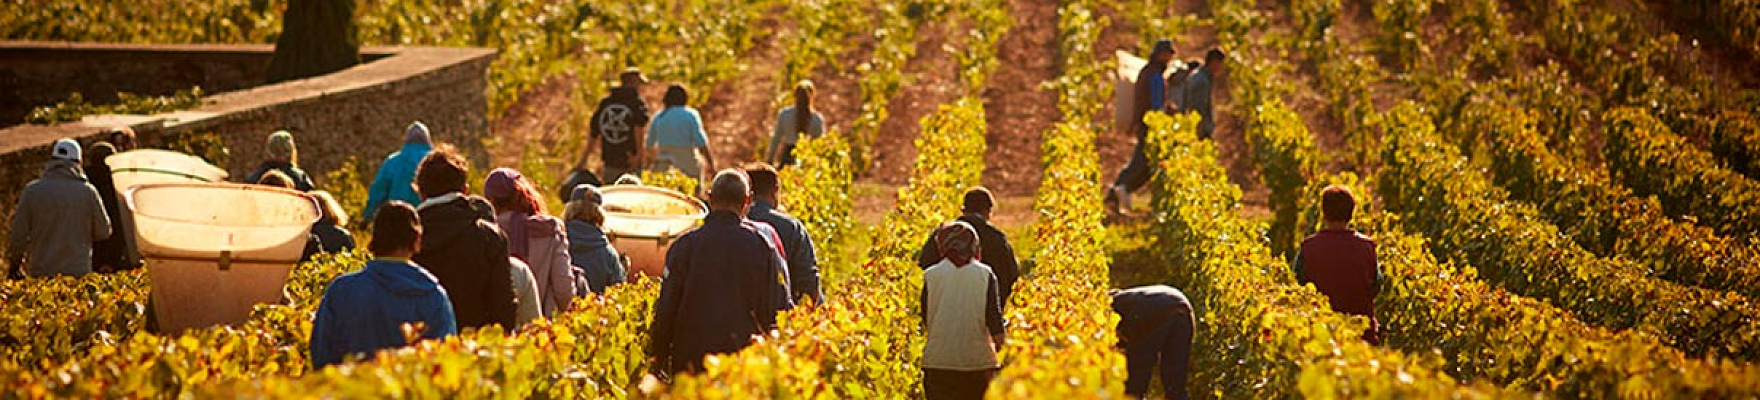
top-left (1105, 39), bottom-right (1174, 213)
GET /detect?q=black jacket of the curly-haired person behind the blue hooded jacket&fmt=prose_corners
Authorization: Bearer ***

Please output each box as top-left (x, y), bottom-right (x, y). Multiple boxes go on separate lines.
top-left (414, 192), bottom-right (519, 330)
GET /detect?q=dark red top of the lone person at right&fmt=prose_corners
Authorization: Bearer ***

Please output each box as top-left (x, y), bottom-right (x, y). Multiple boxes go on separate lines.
top-left (1294, 229), bottom-right (1382, 342)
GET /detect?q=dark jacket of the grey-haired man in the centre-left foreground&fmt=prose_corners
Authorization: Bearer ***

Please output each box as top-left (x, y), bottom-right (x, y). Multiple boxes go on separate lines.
top-left (648, 210), bottom-right (781, 370)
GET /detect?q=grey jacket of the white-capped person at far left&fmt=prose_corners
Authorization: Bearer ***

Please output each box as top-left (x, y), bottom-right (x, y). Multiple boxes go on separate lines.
top-left (7, 160), bottom-right (111, 277)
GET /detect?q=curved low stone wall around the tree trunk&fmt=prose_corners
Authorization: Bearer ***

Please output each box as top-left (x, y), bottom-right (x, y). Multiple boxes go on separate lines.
top-left (0, 42), bottom-right (496, 245)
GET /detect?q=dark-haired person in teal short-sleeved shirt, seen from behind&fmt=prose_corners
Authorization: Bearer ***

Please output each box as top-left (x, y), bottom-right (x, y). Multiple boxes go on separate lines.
top-left (648, 83), bottom-right (715, 187)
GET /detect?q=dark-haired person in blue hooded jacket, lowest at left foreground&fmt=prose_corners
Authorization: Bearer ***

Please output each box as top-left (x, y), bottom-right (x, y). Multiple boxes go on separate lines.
top-left (312, 201), bottom-right (458, 368)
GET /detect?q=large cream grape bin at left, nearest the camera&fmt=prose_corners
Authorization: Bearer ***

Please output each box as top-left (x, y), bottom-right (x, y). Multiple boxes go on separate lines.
top-left (127, 183), bottom-right (319, 333)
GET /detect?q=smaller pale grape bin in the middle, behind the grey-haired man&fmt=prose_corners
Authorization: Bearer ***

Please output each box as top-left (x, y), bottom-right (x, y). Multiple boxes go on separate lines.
top-left (598, 185), bottom-right (708, 280)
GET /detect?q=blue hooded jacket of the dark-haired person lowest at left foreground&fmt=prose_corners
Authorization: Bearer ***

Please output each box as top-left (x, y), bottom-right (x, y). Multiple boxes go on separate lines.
top-left (312, 259), bottom-right (458, 368)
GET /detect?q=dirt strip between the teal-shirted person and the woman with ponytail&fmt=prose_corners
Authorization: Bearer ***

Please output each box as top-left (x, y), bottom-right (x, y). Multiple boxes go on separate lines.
top-left (700, 4), bottom-right (794, 167)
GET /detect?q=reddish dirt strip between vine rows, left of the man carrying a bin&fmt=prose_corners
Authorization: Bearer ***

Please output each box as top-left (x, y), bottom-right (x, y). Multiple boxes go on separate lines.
top-left (984, 0), bottom-right (1063, 196)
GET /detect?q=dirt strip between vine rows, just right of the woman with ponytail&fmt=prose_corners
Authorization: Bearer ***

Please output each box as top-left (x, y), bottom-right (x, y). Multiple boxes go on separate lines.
top-left (861, 18), bottom-right (978, 185)
